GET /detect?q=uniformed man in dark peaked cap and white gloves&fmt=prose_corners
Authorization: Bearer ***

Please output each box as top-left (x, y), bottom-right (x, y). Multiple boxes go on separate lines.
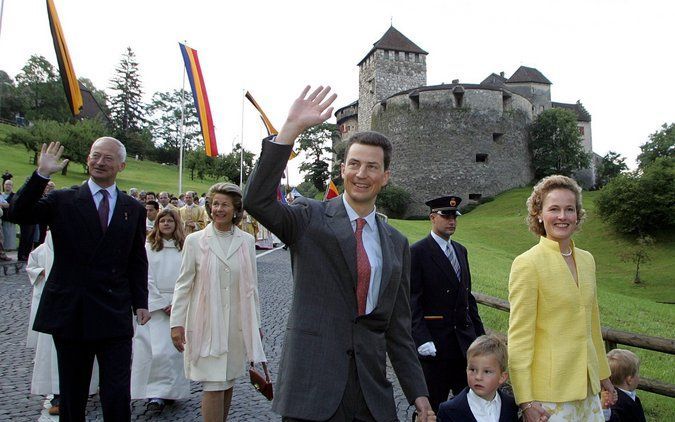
top-left (410, 196), bottom-right (485, 411)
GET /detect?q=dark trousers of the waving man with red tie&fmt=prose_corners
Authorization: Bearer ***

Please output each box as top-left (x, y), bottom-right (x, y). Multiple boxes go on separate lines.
top-left (282, 357), bottom-right (375, 422)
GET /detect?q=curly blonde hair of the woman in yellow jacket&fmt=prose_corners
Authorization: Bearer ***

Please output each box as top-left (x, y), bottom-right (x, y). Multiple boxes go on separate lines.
top-left (526, 174), bottom-right (586, 236)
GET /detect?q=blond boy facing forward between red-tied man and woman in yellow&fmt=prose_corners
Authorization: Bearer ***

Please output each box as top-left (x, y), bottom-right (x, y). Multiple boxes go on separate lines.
top-left (438, 335), bottom-right (518, 422)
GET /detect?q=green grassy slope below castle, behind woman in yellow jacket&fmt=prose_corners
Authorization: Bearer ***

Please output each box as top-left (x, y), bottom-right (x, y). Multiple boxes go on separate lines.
top-left (390, 188), bottom-right (675, 421)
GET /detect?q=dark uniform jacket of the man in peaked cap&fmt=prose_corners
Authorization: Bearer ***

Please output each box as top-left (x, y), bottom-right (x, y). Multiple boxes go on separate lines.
top-left (410, 235), bottom-right (485, 360)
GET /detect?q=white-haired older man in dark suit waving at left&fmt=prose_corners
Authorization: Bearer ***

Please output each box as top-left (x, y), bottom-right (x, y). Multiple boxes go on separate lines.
top-left (10, 137), bottom-right (150, 421)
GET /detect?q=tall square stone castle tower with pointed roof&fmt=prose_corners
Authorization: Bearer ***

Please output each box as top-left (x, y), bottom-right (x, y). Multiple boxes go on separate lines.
top-left (358, 26), bottom-right (428, 131)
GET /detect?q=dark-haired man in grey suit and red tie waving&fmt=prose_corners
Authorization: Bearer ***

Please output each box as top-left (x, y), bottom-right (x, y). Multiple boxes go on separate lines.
top-left (244, 86), bottom-right (435, 421)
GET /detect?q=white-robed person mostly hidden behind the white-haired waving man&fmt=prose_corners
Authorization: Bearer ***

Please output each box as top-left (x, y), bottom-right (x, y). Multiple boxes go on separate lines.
top-left (26, 231), bottom-right (98, 415)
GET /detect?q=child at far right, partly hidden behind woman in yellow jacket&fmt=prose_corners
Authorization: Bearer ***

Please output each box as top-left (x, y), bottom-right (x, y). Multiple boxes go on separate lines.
top-left (604, 349), bottom-right (646, 422)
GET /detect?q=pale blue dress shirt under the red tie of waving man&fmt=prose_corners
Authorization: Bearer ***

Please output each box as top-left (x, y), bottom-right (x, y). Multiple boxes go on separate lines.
top-left (342, 195), bottom-right (382, 314)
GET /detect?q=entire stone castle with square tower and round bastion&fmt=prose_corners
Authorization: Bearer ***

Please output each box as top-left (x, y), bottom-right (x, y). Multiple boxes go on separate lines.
top-left (333, 26), bottom-right (595, 215)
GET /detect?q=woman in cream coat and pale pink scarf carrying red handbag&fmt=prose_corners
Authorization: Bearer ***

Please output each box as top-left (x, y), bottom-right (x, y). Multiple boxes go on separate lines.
top-left (171, 183), bottom-right (266, 422)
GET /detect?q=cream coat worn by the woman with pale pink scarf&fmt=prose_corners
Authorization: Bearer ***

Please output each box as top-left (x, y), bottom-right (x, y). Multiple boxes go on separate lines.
top-left (171, 224), bottom-right (260, 382)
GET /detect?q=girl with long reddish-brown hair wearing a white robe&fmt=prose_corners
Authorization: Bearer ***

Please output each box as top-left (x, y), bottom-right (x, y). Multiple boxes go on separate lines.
top-left (131, 209), bottom-right (190, 411)
